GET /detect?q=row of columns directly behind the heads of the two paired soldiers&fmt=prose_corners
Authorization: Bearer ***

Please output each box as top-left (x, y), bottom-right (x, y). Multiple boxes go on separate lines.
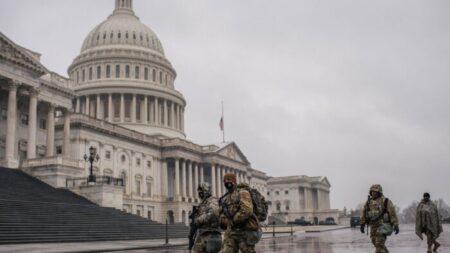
top-left (173, 158), bottom-right (249, 200)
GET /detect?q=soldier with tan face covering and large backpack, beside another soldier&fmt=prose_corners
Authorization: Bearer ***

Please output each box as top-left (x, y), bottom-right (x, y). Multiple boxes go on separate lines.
top-left (219, 173), bottom-right (261, 253)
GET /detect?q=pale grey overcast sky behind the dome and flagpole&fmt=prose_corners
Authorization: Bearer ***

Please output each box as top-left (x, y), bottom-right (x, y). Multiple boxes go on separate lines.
top-left (0, 0), bottom-right (450, 209)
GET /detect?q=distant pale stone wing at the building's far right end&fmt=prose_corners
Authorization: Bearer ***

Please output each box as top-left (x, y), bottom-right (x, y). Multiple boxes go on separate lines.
top-left (267, 176), bottom-right (339, 224)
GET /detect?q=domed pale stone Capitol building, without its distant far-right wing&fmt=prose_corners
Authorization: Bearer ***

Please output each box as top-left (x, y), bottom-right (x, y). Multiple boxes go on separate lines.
top-left (0, 0), bottom-right (336, 223)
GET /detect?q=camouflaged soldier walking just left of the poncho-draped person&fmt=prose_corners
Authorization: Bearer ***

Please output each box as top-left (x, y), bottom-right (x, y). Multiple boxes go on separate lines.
top-left (361, 184), bottom-right (400, 253)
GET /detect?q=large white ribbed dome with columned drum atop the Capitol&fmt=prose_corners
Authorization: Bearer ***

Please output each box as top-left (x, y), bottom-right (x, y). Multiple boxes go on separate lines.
top-left (68, 0), bottom-right (186, 138)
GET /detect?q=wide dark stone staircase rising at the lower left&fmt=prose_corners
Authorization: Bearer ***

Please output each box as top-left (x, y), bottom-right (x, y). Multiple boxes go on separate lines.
top-left (0, 167), bottom-right (188, 244)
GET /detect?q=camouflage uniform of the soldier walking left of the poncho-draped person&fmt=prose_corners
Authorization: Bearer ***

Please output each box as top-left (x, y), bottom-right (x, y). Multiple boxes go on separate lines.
top-left (361, 184), bottom-right (398, 253)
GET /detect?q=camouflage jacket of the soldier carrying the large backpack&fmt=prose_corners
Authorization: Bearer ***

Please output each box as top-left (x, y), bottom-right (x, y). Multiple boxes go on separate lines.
top-left (220, 184), bottom-right (258, 231)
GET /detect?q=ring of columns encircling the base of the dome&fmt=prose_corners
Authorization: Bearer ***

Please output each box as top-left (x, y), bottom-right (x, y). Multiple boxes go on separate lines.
top-left (75, 93), bottom-right (184, 131)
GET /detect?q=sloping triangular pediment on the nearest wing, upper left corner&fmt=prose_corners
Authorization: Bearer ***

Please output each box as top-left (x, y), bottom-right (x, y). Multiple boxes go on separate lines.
top-left (0, 33), bottom-right (48, 76)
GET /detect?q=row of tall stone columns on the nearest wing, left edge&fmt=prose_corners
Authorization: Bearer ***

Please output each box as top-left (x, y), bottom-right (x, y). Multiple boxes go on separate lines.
top-left (5, 80), bottom-right (70, 165)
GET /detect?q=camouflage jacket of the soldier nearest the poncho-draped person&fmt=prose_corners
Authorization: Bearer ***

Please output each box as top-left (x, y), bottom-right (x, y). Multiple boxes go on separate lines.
top-left (361, 196), bottom-right (398, 225)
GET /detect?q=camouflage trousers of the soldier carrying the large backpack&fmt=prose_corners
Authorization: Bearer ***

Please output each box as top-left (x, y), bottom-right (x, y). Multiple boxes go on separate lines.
top-left (220, 230), bottom-right (256, 253)
